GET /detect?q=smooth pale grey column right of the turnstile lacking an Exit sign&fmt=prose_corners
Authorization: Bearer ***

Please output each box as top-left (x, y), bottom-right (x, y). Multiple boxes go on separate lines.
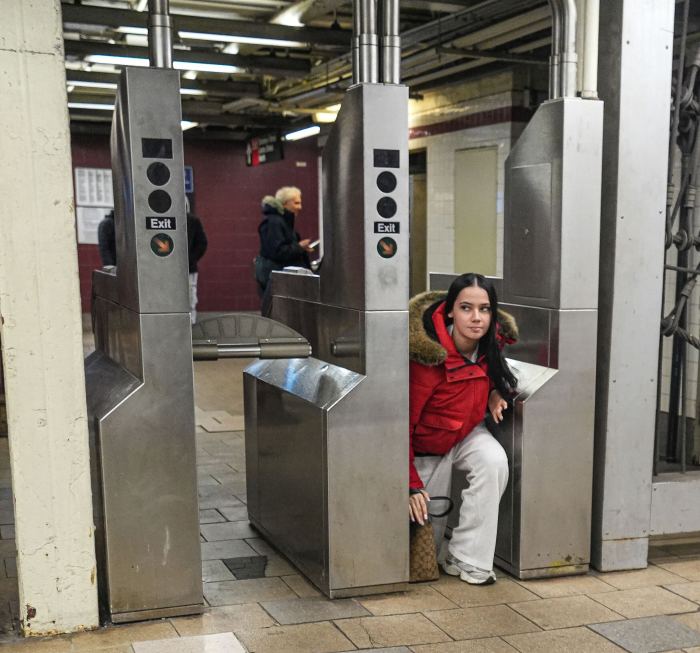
top-left (592, 0), bottom-right (674, 571)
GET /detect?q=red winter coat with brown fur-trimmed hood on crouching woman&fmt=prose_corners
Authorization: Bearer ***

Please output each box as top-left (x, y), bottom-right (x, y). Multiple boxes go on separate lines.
top-left (409, 291), bottom-right (517, 489)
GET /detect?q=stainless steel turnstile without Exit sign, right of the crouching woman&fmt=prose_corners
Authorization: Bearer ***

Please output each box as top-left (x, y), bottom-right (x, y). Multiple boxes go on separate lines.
top-left (431, 98), bottom-right (603, 578)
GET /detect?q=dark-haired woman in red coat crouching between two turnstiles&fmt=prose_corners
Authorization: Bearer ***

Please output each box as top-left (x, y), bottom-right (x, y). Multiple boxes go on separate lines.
top-left (409, 273), bottom-right (517, 585)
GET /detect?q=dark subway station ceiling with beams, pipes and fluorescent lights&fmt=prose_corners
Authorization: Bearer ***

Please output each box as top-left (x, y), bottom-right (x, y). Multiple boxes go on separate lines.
top-left (62, 0), bottom-right (551, 140)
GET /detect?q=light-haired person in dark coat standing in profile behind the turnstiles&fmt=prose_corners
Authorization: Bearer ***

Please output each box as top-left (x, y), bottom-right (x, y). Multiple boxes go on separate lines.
top-left (255, 186), bottom-right (313, 315)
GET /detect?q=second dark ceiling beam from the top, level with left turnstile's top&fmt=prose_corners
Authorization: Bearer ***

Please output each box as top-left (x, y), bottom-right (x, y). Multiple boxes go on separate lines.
top-left (65, 40), bottom-right (311, 77)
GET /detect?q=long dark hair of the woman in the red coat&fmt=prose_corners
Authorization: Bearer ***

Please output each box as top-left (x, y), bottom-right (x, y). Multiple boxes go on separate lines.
top-left (445, 272), bottom-right (518, 398)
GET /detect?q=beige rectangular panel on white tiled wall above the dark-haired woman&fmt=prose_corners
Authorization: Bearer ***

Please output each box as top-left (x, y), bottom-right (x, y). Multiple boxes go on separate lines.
top-left (454, 147), bottom-right (498, 276)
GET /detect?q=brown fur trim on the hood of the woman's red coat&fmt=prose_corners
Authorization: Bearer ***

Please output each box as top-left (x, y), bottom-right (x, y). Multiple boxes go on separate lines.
top-left (408, 290), bottom-right (518, 366)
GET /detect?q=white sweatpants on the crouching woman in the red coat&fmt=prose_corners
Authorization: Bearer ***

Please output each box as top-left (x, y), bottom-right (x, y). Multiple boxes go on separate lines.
top-left (415, 422), bottom-right (508, 570)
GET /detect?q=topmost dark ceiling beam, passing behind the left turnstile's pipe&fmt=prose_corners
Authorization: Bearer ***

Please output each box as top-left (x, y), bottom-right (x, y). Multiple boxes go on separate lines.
top-left (61, 4), bottom-right (352, 49)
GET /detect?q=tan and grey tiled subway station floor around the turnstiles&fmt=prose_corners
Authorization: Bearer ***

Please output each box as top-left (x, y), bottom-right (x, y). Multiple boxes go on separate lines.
top-left (0, 318), bottom-right (700, 653)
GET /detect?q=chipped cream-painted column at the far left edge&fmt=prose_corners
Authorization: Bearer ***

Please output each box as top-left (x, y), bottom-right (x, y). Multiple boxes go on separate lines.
top-left (0, 0), bottom-right (98, 635)
